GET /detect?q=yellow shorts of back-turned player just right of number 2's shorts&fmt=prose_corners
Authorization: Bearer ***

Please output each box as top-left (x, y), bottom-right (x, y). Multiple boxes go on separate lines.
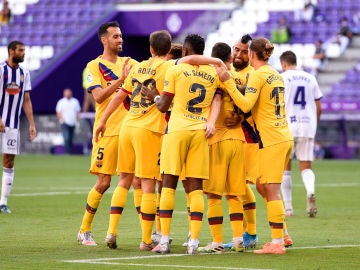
top-left (203, 140), bottom-right (245, 196)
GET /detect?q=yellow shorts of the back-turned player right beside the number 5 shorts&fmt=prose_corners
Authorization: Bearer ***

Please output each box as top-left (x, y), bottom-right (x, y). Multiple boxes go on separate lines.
top-left (117, 126), bottom-right (162, 179)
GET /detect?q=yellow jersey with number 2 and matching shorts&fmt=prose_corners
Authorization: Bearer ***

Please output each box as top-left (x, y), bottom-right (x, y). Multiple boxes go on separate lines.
top-left (160, 64), bottom-right (220, 179)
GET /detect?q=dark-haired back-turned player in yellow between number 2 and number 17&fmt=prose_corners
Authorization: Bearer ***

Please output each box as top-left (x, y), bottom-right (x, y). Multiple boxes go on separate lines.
top-left (198, 42), bottom-right (245, 253)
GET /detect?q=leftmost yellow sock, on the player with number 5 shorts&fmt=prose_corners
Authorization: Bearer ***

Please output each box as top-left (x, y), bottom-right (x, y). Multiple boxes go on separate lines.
top-left (80, 188), bottom-right (103, 232)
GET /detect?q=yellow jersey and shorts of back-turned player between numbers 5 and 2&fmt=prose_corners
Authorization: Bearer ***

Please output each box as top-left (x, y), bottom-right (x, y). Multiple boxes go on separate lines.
top-left (118, 57), bottom-right (175, 179)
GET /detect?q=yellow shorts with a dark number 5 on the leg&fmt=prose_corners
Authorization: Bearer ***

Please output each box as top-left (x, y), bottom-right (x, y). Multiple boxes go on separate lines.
top-left (89, 136), bottom-right (119, 175)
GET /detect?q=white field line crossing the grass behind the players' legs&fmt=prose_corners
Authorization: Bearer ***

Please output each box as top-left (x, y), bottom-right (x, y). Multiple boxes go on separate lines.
top-left (11, 183), bottom-right (360, 197)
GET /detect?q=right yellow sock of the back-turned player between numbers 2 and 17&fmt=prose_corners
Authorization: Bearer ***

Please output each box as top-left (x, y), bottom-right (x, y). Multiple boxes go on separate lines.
top-left (227, 197), bottom-right (244, 238)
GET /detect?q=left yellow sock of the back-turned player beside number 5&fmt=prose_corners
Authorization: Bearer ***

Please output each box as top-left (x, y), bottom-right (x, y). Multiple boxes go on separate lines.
top-left (107, 186), bottom-right (129, 235)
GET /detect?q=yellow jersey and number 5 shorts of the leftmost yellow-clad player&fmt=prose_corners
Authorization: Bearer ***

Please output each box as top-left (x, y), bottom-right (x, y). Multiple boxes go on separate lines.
top-left (84, 56), bottom-right (137, 175)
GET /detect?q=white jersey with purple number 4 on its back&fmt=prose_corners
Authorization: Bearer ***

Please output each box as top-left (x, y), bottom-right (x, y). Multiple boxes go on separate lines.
top-left (281, 69), bottom-right (323, 138)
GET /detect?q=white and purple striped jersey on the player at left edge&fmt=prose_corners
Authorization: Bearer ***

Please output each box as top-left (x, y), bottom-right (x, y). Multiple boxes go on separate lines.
top-left (0, 62), bottom-right (31, 129)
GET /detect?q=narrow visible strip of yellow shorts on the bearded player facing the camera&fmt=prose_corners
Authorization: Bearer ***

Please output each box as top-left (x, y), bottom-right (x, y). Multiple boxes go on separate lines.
top-left (244, 143), bottom-right (259, 184)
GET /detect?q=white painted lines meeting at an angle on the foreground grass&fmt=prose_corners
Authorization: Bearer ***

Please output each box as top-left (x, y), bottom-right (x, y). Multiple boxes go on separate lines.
top-left (64, 245), bottom-right (360, 270)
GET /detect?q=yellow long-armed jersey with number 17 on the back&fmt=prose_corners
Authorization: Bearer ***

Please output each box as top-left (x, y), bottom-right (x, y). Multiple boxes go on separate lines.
top-left (224, 65), bottom-right (293, 148)
